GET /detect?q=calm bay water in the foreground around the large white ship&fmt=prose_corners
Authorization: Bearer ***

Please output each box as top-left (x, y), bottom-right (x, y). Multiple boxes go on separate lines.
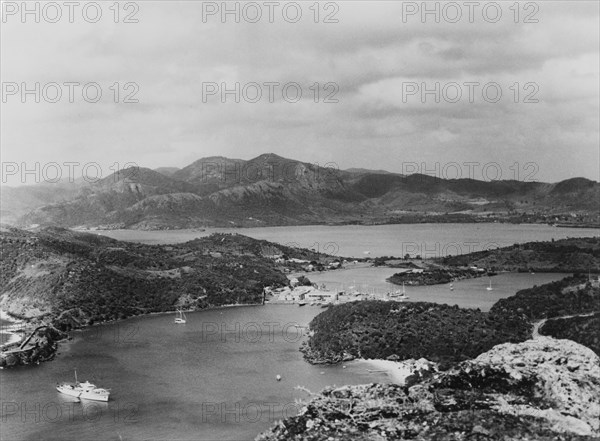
top-left (0, 305), bottom-right (387, 441)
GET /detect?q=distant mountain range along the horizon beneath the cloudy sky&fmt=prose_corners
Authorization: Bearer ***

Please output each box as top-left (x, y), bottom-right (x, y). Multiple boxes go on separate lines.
top-left (1, 153), bottom-right (600, 229)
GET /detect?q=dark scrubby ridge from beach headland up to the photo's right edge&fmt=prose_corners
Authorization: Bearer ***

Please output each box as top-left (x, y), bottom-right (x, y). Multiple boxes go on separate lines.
top-left (301, 276), bottom-right (600, 363)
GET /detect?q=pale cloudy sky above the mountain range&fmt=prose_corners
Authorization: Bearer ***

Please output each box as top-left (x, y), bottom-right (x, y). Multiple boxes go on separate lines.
top-left (1, 1), bottom-right (600, 185)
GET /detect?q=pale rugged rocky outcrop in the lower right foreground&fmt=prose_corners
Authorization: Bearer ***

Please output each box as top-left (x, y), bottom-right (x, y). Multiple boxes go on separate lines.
top-left (257, 337), bottom-right (600, 441)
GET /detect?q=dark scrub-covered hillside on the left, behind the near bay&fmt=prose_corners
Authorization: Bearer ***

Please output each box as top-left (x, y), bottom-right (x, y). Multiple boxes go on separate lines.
top-left (0, 227), bottom-right (320, 328)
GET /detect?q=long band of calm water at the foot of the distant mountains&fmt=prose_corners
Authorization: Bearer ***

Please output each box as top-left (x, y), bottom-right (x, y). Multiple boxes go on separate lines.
top-left (98, 224), bottom-right (600, 257)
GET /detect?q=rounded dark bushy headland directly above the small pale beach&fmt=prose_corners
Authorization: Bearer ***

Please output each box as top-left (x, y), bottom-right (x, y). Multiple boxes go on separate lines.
top-left (302, 301), bottom-right (531, 363)
